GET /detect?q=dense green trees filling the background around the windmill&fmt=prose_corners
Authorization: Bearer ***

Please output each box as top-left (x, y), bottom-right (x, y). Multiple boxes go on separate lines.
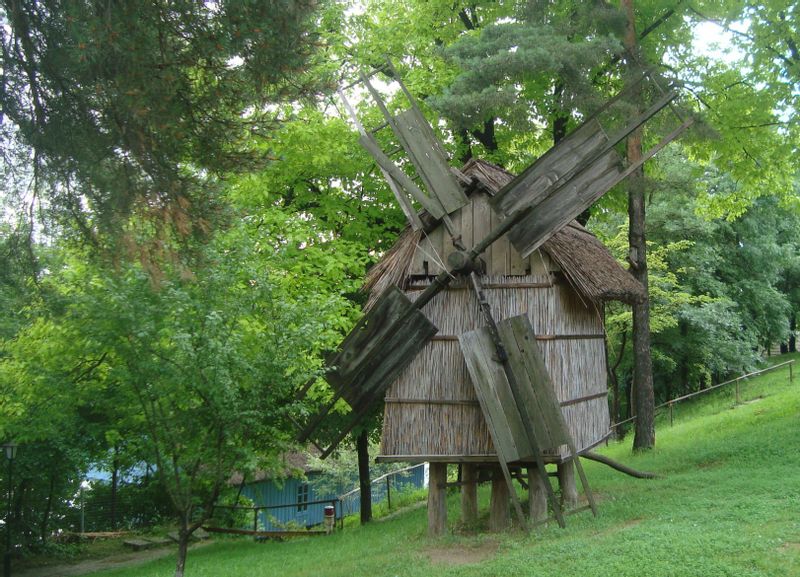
top-left (0, 0), bottom-right (800, 572)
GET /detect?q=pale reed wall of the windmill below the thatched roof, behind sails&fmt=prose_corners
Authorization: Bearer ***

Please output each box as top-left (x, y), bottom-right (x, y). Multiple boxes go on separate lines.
top-left (381, 275), bottom-right (609, 462)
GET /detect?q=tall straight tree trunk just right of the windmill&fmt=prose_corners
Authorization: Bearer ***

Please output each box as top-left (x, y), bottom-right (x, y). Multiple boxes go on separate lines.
top-left (620, 0), bottom-right (656, 450)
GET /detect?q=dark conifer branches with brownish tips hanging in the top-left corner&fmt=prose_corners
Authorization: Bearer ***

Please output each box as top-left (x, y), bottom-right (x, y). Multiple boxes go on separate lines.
top-left (0, 0), bottom-right (322, 248)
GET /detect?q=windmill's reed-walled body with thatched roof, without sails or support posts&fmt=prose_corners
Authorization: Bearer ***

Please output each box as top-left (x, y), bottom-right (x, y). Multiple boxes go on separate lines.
top-left (368, 160), bottom-right (642, 465)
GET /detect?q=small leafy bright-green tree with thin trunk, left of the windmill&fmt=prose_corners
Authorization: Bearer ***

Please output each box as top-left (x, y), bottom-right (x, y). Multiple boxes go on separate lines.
top-left (0, 213), bottom-right (360, 576)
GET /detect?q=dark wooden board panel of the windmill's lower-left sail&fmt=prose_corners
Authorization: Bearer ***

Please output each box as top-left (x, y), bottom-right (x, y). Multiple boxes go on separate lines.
top-left (325, 286), bottom-right (438, 410)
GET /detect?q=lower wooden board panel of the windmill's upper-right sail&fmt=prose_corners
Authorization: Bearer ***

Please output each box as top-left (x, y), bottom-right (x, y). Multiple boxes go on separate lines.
top-left (508, 149), bottom-right (622, 258)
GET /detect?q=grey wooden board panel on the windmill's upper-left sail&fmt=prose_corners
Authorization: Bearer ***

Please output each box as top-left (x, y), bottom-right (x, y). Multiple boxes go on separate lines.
top-left (394, 108), bottom-right (468, 214)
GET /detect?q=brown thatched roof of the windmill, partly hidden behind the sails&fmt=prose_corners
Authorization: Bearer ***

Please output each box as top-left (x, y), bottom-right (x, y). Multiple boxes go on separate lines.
top-left (364, 159), bottom-right (644, 308)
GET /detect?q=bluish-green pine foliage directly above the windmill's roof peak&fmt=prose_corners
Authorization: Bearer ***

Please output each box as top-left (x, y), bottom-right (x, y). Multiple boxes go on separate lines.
top-left (432, 1), bottom-right (623, 130)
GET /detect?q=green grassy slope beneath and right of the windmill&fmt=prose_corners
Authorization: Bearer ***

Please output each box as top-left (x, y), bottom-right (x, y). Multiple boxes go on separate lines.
top-left (89, 355), bottom-right (800, 577)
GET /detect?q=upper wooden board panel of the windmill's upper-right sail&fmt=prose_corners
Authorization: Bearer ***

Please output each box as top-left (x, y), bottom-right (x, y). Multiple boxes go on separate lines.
top-left (492, 119), bottom-right (608, 216)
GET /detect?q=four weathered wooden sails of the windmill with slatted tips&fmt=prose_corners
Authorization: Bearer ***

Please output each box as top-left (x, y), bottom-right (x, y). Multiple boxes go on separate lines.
top-left (299, 63), bottom-right (690, 526)
